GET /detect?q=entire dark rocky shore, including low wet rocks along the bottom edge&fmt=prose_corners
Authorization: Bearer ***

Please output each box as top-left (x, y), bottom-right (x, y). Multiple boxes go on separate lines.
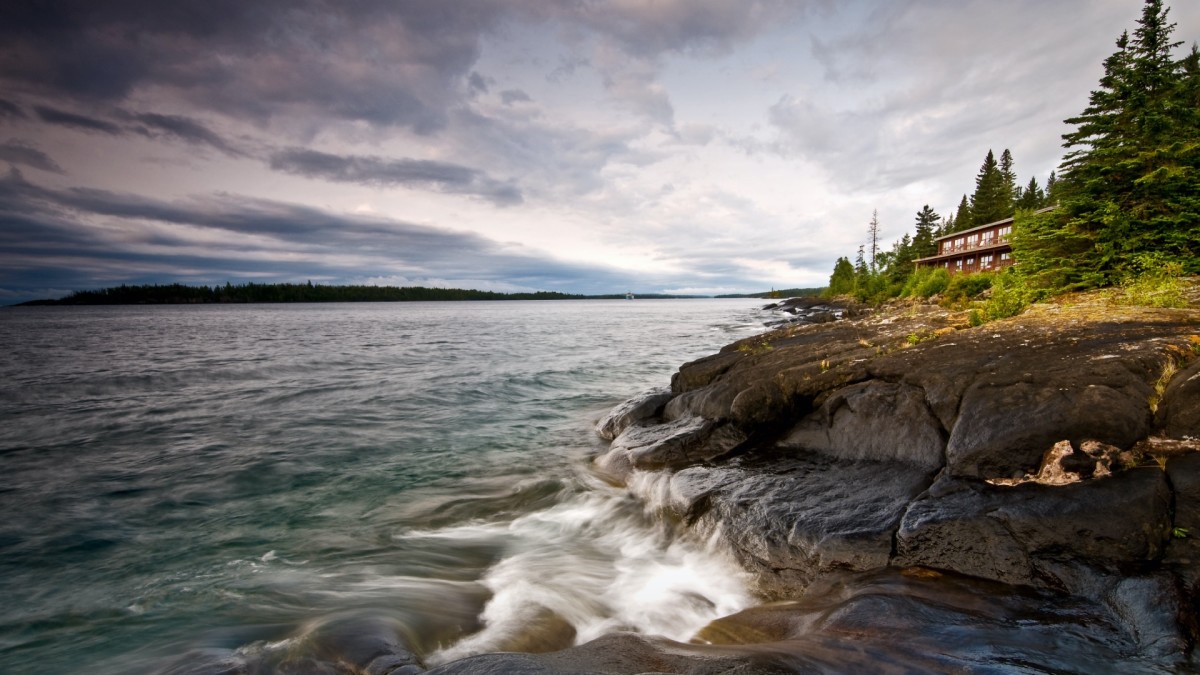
top-left (164, 285), bottom-right (1200, 675)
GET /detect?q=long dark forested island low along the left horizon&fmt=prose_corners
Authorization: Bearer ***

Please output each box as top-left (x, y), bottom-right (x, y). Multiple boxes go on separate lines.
top-left (22, 281), bottom-right (696, 306)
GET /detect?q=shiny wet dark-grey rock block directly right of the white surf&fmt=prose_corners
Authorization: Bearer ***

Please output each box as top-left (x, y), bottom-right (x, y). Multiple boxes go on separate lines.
top-left (670, 454), bottom-right (930, 597)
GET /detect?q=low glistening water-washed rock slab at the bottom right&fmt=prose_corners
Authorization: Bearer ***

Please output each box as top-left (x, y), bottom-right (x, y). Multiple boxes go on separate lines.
top-left (697, 568), bottom-right (1188, 673)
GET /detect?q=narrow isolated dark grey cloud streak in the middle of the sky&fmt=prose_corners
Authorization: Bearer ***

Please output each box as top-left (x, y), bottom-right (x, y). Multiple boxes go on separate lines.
top-left (270, 148), bottom-right (522, 205)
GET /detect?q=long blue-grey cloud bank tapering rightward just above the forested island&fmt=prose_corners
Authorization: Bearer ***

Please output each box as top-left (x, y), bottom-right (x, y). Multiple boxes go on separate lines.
top-left (0, 171), bottom-right (624, 299)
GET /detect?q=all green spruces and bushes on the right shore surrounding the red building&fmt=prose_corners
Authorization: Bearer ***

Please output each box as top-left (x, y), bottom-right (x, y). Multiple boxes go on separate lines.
top-left (828, 0), bottom-right (1200, 312)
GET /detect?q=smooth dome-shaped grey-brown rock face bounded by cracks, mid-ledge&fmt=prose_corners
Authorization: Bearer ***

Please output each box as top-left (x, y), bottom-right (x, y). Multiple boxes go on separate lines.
top-left (780, 381), bottom-right (946, 471)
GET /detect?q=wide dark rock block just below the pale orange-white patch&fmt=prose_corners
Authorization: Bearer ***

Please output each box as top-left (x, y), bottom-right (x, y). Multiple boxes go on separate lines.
top-left (892, 468), bottom-right (1171, 587)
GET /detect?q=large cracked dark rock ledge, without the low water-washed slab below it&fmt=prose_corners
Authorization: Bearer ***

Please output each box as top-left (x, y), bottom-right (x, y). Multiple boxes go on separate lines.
top-left (580, 295), bottom-right (1200, 671)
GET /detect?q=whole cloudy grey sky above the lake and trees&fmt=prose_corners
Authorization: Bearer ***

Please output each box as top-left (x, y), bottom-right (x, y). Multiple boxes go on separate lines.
top-left (0, 0), bottom-right (1200, 303)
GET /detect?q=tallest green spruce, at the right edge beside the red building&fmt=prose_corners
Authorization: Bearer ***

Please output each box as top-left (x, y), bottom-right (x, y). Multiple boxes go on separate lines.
top-left (1058, 0), bottom-right (1200, 281)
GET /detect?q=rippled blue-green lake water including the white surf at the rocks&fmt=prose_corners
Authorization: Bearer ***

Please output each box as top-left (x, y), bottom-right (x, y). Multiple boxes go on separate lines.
top-left (0, 300), bottom-right (768, 673)
